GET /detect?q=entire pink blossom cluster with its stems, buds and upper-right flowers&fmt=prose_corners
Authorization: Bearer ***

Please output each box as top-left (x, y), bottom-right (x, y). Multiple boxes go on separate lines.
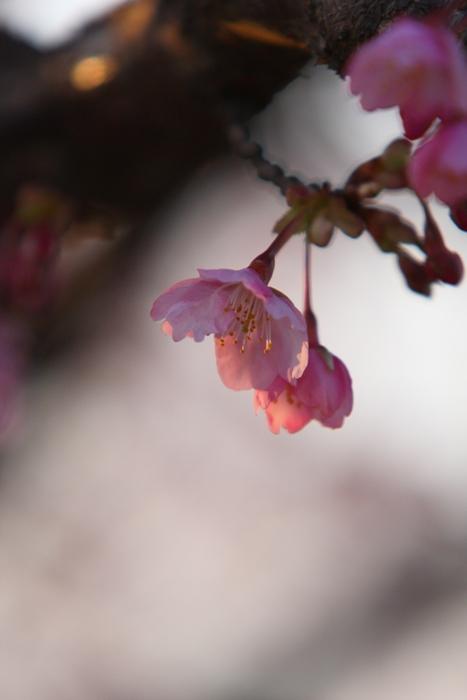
top-left (152, 8), bottom-right (467, 433)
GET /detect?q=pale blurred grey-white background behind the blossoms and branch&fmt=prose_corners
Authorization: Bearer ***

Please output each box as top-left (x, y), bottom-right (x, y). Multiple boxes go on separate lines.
top-left (0, 0), bottom-right (467, 700)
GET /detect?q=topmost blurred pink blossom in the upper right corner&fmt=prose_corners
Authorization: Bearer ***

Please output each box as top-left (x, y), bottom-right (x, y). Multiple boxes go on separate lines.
top-left (347, 19), bottom-right (467, 139)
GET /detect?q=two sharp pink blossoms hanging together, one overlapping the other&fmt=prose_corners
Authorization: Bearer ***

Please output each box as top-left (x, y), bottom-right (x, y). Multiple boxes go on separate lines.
top-left (151, 258), bottom-right (352, 433)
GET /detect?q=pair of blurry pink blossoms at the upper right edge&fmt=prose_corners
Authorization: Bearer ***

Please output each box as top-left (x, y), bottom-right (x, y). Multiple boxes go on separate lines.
top-left (347, 19), bottom-right (467, 224)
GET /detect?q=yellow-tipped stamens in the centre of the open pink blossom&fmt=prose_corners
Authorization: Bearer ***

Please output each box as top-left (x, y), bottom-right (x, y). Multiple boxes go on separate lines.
top-left (219, 285), bottom-right (272, 353)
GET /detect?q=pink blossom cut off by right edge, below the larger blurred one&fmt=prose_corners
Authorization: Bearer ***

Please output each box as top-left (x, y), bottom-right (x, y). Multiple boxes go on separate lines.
top-left (408, 120), bottom-right (467, 205)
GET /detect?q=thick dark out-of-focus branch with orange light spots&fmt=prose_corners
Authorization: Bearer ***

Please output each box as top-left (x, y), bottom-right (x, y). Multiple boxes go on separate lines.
top-left (0, 0), bottom-right (458, 218)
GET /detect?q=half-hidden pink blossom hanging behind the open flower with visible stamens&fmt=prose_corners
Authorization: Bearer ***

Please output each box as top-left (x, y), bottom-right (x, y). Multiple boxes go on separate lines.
top-left (254, 346), bottom-right (353, 433)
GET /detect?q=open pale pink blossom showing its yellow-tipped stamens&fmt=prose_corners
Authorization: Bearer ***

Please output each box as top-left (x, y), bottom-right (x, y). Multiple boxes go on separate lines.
top-left (151, 268), bottom-right (308, 389)
